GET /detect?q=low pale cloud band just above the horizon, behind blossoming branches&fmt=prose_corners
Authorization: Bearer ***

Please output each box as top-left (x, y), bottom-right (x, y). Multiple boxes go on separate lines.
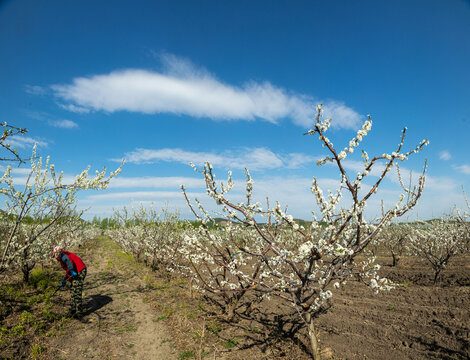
top-left (74, 165), bottom-right (463, 220)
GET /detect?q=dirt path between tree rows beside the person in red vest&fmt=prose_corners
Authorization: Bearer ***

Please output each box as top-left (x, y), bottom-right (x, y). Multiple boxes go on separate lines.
top-left (47, 239), bottom-right (176, 360)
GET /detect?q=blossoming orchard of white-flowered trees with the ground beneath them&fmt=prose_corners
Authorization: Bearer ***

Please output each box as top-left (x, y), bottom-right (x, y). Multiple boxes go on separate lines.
top-left (0, 111), bottom-right (470, 360)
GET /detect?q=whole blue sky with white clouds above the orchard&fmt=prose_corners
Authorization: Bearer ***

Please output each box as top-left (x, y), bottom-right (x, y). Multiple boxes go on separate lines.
top-left (0, 0), bottom-right (470, 219)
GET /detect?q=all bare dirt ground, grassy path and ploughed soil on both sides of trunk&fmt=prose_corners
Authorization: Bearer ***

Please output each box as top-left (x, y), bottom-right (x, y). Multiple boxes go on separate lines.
top-left (0, 238), bottom-right (470, 360)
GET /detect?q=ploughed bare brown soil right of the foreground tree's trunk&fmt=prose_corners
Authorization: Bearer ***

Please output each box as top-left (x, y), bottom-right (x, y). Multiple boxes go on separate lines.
top-left (319, 257), bottom-right (470, 360)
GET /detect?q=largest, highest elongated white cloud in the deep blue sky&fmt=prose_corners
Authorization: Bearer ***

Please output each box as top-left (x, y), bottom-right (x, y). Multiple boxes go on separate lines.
top-left (52, 55), bottom-right (361, 128)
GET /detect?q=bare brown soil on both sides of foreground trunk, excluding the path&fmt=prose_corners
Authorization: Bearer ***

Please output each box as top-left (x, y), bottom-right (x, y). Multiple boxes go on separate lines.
top-left (151, 256), bottom-right (470, 360)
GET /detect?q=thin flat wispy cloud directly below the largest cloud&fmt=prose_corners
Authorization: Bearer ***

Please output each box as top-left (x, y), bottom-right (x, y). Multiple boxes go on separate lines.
top-left (114, 148), bottom-right (317, 170)
